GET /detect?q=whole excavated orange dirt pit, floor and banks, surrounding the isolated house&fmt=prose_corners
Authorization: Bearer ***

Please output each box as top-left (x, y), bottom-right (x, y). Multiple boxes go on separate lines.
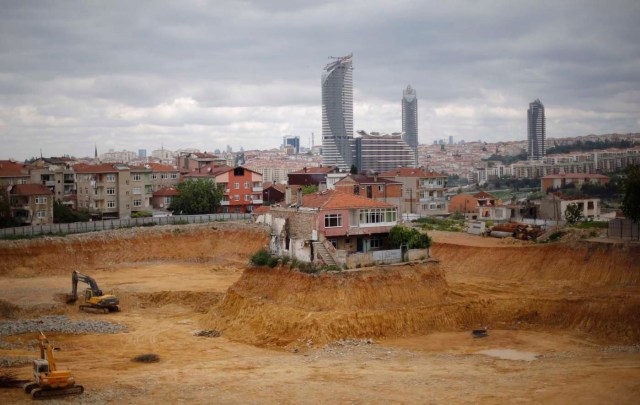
top-left (0, 224), bottom-right (640, 404)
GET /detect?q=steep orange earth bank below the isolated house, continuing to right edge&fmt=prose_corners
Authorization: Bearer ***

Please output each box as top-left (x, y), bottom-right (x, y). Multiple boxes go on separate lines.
top-left (203, 243), bottom-right (640, 346)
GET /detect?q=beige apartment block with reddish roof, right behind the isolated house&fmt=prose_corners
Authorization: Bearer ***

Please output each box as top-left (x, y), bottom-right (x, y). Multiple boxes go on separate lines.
top-left (380, 167), bottom-right (449, 216)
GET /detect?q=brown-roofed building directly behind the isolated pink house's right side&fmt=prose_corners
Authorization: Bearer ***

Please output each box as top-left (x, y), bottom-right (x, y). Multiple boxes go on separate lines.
top-left (334, 174), bottom-right (404, 214)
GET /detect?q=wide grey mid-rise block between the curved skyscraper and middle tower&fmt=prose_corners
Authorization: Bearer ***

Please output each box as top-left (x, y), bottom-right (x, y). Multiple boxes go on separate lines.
top-left (355, 131), bottom-right (417, 173)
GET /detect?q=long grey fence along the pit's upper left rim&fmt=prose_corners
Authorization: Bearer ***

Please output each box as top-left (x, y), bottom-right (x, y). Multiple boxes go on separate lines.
top-left (0, 213), bottom-right (251, 238)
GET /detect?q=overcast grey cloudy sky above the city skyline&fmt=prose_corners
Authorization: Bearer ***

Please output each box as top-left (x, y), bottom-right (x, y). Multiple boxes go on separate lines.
top-left (0, 0), bottom-right (640, 160)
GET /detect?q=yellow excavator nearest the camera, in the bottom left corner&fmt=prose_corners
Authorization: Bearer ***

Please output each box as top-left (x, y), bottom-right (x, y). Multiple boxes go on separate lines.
top-left (24, 332), bottom-right (84, 399)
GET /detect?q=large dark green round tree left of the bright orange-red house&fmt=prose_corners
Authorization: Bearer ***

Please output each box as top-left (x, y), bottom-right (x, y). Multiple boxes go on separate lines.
top-left (170, 179), bottom-right (222, 215)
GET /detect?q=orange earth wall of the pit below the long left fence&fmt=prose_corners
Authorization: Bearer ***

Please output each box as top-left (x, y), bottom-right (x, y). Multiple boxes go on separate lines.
top-left (0, 223), bottom-right (269, 277)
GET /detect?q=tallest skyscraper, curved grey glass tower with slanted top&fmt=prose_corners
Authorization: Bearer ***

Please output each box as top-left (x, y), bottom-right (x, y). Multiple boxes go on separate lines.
top-left (322, 54), bottom-right (354, 170)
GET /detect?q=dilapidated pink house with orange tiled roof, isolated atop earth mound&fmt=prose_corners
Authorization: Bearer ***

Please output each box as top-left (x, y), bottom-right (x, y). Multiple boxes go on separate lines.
top-left (258, 190), bottom-right (401, 267)
